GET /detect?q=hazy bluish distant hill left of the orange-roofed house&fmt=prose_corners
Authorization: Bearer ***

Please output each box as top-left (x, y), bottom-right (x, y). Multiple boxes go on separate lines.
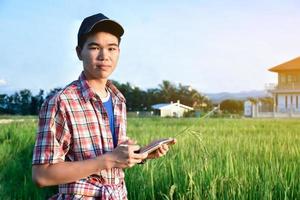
top-left (204, 90), bottom-right (270, 103)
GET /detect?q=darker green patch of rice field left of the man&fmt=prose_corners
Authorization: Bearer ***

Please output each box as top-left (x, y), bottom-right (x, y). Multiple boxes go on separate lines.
top-left (0, 119), bottom-right (57, 199)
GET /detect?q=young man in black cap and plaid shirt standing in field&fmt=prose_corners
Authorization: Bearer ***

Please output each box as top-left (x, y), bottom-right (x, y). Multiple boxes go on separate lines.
top-left (32, 13), bottom-right (175, 199)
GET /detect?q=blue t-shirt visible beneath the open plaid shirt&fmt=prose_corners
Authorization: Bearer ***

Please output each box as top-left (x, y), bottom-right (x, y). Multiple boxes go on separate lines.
top-left (102, 92), bottom-right (118, 147)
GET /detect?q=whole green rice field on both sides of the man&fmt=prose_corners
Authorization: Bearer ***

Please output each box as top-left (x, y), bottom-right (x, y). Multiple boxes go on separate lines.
top-left (0, 118), bottom-right (300, 200)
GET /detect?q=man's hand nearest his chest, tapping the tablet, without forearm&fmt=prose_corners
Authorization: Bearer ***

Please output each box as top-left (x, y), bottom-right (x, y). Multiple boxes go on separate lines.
top-left (109, 139), bottom-right (148, 168)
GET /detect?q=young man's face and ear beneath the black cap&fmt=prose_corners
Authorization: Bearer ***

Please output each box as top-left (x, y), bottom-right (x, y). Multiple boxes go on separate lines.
top-left (77, 32), bottom-right (120, 80)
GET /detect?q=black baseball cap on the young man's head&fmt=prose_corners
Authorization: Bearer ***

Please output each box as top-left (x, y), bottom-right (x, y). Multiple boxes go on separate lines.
top-left (77, 13), bottom-right (124, 46)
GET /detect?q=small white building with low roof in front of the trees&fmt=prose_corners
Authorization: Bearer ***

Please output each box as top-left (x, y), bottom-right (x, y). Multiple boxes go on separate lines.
top-left (151, 101), bottom-right (194, 117)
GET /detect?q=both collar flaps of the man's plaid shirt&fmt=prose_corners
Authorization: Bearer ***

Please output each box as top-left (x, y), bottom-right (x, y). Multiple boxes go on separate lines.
top-left (78, 72), bottom-right (126, 102)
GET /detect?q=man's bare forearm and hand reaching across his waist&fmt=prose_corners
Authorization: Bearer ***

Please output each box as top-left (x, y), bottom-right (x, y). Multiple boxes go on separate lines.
top-left (32, 140), bottom-right (148, 187)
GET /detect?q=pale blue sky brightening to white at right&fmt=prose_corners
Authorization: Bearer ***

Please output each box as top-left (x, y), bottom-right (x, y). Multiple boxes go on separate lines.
top-left (0, 0), bottom-right (300, 93)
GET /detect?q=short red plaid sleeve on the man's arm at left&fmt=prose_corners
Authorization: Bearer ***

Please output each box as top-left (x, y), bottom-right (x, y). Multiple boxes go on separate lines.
top-left (32, 97), bottom-right (70, 164)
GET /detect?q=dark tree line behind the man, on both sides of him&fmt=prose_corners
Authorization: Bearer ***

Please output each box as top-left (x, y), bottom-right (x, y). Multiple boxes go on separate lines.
top-left (0, 81), bottom-right (212, 115)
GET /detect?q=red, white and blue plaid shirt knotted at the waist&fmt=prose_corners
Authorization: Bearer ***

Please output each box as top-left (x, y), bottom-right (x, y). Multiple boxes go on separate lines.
top-left (32, 73), bottom-right (127, 199)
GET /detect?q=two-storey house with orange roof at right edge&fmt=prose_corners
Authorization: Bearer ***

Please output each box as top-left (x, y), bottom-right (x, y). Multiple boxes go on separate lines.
top-left (244, 57), bottom-right (300, 118)
